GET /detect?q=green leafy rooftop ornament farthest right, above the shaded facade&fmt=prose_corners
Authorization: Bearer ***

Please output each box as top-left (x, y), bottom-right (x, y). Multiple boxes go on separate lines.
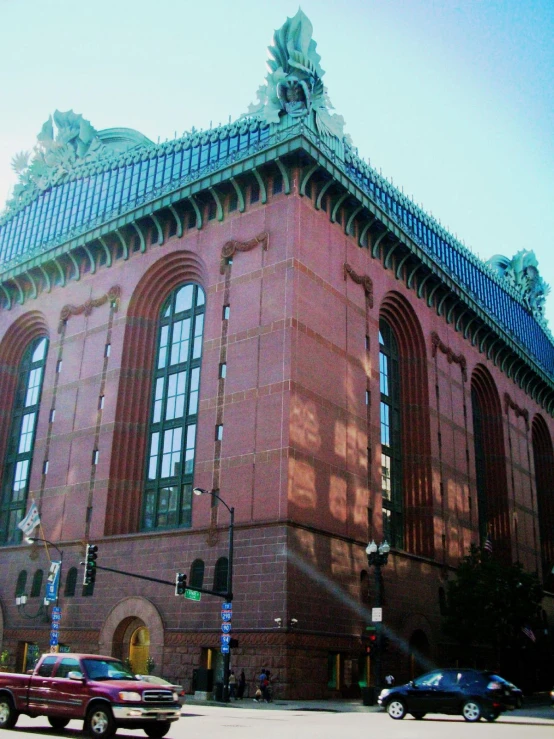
top-left (487, 249), bottom-right (550, 322)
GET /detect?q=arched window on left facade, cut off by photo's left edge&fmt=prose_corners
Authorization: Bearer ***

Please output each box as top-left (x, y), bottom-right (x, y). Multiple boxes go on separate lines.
top-left (0, 337), bottom-right (48, 544)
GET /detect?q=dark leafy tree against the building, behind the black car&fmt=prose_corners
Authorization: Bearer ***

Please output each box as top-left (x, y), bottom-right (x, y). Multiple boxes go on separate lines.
top-left (443, 545), bottom-right (543, 661)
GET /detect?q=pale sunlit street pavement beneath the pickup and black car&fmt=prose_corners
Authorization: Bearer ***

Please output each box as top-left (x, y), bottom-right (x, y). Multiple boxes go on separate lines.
top-left (6, 704), bottom-right (554, 739)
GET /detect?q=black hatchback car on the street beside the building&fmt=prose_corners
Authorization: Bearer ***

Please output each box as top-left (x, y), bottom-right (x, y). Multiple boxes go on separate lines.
top-left (378, 668), bottom-right (517, 721)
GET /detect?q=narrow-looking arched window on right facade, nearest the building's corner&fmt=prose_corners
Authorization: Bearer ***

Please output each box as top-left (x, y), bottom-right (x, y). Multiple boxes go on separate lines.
top-left (379, 320), bottom-right (404, 548)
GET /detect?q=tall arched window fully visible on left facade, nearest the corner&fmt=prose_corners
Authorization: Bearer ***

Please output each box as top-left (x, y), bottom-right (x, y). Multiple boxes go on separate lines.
top-left (142, 284), bottom-right (205, 529)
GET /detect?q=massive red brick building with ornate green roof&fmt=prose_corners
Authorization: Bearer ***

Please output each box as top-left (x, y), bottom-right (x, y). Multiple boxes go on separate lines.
top-left (0, 11), bottom-right (554, 698)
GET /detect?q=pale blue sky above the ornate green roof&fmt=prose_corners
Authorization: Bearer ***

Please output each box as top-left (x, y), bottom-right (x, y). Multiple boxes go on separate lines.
top-left (0, 0), bottom-right (554, 331)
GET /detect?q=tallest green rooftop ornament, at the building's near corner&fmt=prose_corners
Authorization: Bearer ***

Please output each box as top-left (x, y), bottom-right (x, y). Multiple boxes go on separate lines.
top-left (247, 8), bottom-right (344, 139)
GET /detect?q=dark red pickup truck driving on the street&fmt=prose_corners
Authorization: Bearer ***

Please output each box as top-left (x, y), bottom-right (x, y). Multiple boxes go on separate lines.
top-left (0, 653), bottom-right (181, 739)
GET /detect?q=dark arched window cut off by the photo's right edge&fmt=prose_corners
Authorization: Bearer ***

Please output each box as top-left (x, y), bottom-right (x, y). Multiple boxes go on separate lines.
top-left (532, 416), bottom-right (554, 589)
